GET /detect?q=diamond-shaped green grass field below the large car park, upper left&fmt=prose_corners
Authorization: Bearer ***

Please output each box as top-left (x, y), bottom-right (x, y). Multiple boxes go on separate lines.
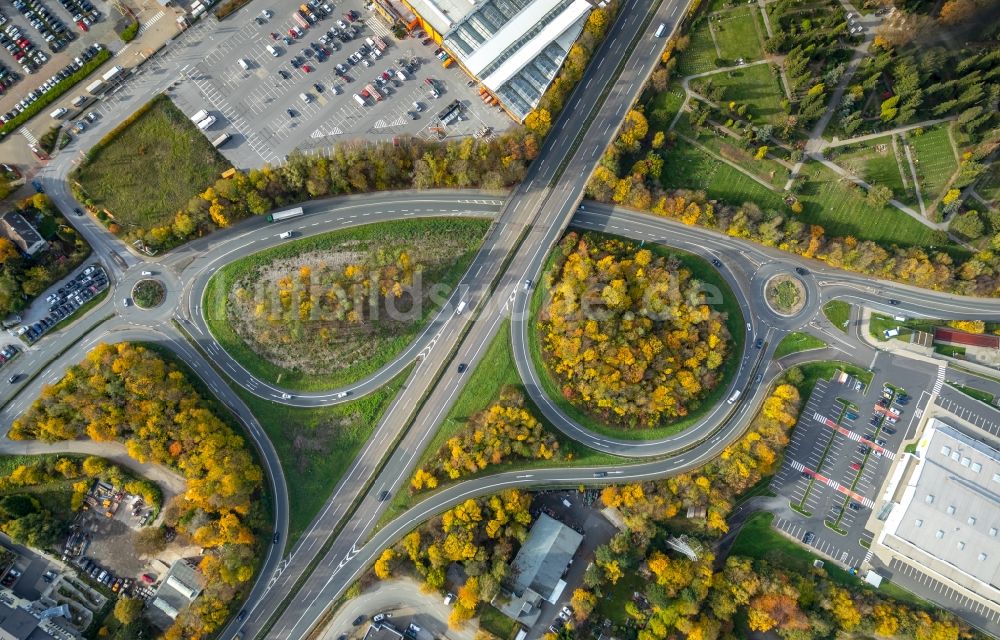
top-left (78, 96), bottom-right (229, 232)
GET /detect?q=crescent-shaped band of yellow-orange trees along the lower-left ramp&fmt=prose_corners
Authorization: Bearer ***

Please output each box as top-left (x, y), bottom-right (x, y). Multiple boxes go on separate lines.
top-left (10, 343), bottom-right (268, 640)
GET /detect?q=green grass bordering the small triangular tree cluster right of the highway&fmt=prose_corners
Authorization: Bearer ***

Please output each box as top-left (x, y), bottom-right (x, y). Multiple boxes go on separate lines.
top-left (379, 320), bottom-right (628, 526)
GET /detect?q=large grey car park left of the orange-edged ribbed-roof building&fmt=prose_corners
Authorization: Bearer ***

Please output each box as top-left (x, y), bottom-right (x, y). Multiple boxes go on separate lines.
top-left (164, 0), bottom-right (512, 167)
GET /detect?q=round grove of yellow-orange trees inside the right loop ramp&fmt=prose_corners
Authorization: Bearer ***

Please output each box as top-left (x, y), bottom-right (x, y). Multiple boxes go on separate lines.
top-left (538, 232), bottom-right (730, 428)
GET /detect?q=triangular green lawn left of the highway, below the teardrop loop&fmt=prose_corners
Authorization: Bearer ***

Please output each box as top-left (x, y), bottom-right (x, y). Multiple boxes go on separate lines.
top-left (236, 365), bottom-right (412, 549)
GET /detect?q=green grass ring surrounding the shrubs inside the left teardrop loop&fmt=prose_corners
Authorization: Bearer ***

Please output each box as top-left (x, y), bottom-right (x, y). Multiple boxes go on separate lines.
top-left (202, 218), bottom-right (490, 391)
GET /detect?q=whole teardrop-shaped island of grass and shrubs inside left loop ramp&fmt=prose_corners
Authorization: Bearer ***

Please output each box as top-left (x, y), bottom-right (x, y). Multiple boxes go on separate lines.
top-left (204, 218), bottom-right (489, 389)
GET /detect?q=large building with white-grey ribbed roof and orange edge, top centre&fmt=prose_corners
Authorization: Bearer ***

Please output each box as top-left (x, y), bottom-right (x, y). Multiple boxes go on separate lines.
top-left (379, 0), bottom-right (598, 121)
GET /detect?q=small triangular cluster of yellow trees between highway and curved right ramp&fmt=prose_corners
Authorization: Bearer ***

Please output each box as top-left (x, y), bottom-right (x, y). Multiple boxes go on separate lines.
top-left (410, 386), bottom-right (563, 492)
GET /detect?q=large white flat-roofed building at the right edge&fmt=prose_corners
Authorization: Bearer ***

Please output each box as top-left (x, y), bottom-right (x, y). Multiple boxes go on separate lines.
top-left (877, 418), bottom-right (1000, 602)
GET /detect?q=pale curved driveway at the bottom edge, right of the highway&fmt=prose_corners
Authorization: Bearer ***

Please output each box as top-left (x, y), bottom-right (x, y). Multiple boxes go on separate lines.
top-left (319, 578), bottom-right (479, 640)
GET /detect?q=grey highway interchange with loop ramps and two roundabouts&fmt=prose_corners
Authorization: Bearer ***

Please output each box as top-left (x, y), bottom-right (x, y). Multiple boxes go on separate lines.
top-left (0, 0), bottom-right (1000, 639)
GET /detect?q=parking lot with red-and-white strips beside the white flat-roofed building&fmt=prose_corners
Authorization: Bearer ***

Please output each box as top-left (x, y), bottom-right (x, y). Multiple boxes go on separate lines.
top-left (771, 357), bottom-right (931, 567)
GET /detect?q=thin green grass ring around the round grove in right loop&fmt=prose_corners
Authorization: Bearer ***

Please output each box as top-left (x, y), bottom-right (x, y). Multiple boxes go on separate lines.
top-left (528, 233), bottom-right (746, 440)
